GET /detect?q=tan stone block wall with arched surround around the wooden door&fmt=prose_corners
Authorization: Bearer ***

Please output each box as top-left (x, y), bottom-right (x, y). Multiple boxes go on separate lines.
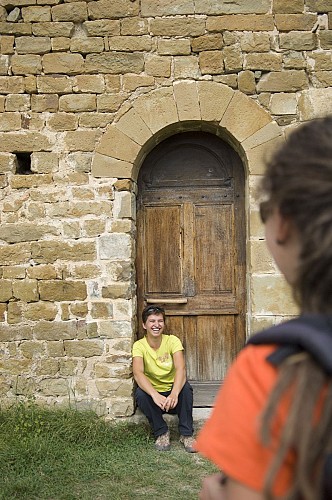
top-left (0, 0), bottom-right (332, 418)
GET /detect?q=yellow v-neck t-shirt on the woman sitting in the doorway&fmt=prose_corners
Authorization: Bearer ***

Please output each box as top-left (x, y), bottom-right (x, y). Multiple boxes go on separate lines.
top-left (133, 335), bottom-right (183, 392)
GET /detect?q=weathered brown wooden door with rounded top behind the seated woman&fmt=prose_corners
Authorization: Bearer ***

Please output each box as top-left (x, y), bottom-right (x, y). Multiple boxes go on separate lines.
top-left (136, 132), bottom-right (246, 406)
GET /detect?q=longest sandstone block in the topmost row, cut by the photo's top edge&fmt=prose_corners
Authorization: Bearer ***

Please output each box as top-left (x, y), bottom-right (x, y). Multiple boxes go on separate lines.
top-left (195, 0), bottom-right (270, 15)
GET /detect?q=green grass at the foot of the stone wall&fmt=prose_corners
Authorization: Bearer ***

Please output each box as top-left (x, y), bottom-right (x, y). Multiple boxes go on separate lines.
top-left (0, 403), bottom-right (215, 500)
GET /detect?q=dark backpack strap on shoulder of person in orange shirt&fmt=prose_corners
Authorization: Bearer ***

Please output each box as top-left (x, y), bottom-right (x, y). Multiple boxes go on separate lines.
top-left (247, 314), bottom-right (332, 375)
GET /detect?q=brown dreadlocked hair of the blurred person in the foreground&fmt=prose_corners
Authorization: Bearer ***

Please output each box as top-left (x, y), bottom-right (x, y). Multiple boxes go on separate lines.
top-left (261, 116), bottom-right (332, 500)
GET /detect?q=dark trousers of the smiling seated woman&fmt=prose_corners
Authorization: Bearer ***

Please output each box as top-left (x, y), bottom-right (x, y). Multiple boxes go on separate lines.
top-left (136, 382), bottom-right (194, 437)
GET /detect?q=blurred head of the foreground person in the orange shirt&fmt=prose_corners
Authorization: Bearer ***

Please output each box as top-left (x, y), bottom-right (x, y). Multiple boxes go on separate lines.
top-left (260, 116), bottom-right (332, 314)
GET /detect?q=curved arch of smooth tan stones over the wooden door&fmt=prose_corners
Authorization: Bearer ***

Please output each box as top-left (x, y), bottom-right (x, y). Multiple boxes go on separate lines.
top-left (92, 80), bottom-right (283, 181)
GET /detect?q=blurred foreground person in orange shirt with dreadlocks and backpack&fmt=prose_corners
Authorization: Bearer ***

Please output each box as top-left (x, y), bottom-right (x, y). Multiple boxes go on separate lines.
top-left (196, 116), bottom-right (332, 500)
